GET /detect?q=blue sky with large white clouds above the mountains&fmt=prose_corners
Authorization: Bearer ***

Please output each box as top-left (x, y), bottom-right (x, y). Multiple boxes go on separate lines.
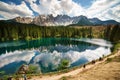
top-left (0, 0), bottom-right (120, 22)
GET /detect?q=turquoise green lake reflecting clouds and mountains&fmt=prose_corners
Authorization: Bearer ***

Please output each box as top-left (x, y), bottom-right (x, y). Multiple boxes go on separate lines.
top-left (0, 38), bottom-right (112, 74)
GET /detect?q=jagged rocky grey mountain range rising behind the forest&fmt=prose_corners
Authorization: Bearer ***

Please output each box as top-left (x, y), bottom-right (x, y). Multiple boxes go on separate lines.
top-left (5, 14), bottom-right (120, 26)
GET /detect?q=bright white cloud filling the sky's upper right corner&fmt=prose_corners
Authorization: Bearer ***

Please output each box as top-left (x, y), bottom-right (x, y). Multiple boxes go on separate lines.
top-left (86, 0), bottom-right (120, 22)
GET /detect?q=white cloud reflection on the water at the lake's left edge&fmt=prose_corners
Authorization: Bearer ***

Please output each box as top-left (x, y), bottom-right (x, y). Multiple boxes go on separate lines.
top-left (0, 51), bottom-right (35, 68)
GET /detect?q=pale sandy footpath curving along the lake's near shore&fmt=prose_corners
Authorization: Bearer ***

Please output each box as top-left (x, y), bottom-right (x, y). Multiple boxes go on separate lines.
top-left (28, 50), bottom-right (120, 80)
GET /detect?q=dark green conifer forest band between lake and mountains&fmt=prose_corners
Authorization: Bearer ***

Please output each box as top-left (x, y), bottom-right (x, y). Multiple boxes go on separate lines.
top-left (0, 21), bottom-right (120, 41)
